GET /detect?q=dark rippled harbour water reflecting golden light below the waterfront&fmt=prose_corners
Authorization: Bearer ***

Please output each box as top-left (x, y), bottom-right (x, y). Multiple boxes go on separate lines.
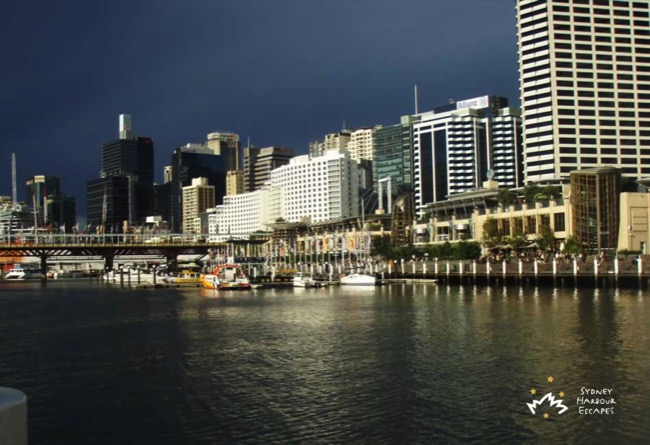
top-left (0, 280), bottom-right (650, 444)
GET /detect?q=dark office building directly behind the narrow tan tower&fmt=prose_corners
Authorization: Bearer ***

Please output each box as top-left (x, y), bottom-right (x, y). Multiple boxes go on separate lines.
top-left (169, 143), bottom-right (228, 231)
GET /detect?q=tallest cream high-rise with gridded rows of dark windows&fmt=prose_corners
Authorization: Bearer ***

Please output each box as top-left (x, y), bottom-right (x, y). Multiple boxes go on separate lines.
top-left (516, 0), bottom-right (650, 181)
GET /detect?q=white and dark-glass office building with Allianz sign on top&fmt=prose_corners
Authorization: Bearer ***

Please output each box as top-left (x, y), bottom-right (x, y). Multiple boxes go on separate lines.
top-left (413, 96), bottom-right (523, 215)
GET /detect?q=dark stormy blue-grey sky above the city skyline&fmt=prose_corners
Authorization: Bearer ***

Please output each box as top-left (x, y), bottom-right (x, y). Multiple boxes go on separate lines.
top-left (0, 0), bottom-right (519, 216)
